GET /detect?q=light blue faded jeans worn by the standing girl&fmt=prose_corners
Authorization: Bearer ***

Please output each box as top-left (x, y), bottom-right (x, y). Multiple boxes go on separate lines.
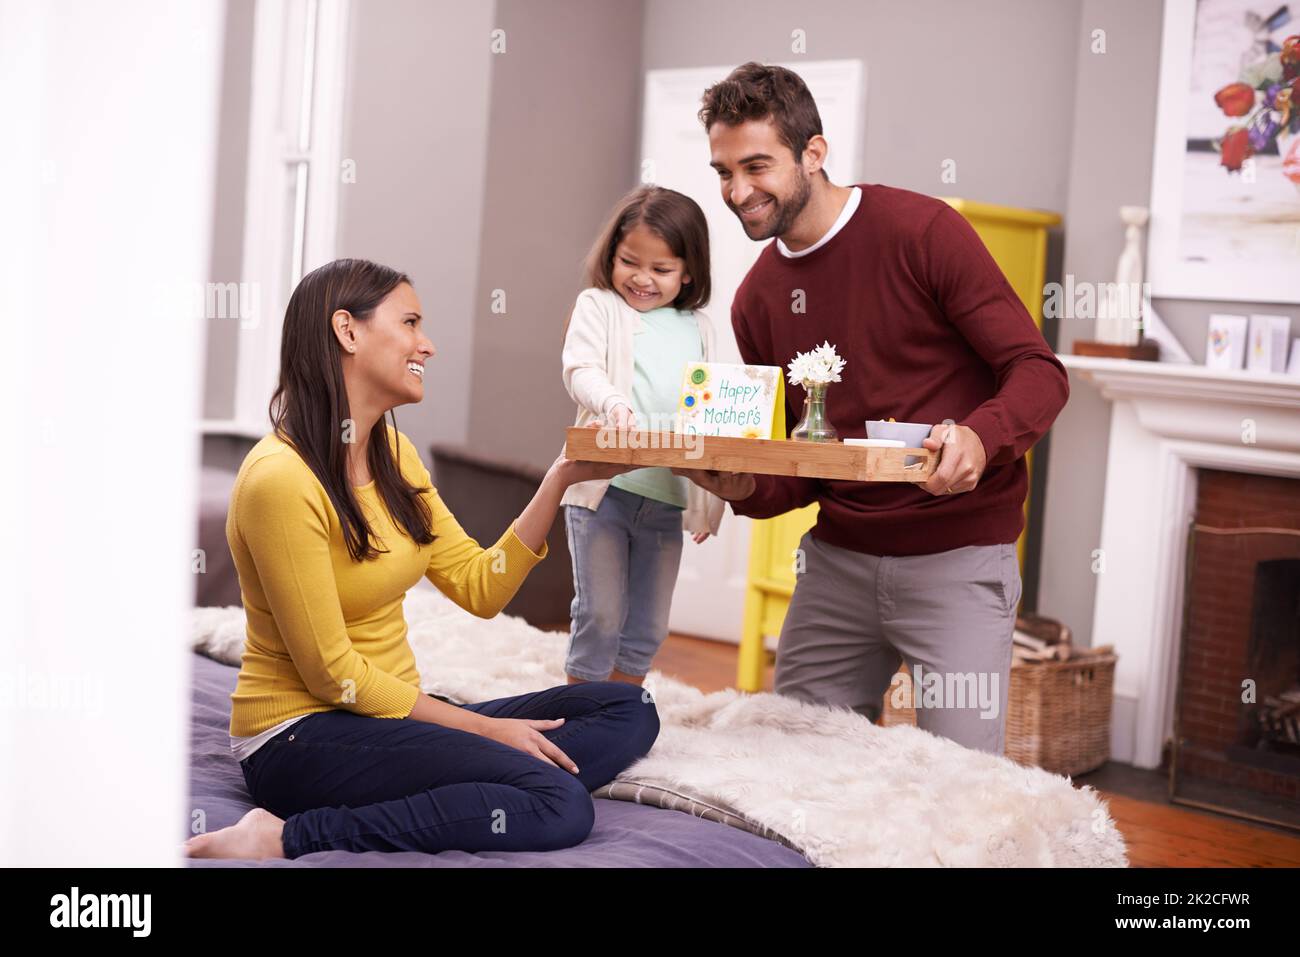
top-left (564, 485), bottom-right (683, 681)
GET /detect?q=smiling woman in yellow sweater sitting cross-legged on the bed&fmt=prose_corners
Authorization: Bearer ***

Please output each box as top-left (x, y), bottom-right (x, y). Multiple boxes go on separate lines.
top-left (186, 260), bottom-right (659, 858)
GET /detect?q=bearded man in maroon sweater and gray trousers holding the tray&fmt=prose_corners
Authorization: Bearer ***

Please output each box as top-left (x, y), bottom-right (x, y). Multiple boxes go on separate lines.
top-left (681, 62), bottom-right (1069, 754)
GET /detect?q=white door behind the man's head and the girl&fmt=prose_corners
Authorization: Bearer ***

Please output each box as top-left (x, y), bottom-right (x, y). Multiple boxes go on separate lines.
top-left (641, 60), bottom-right (866, 642)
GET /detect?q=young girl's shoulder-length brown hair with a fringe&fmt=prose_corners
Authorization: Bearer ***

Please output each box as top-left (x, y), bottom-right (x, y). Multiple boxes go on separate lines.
top-left (586, 186), bottom-right (712, 317)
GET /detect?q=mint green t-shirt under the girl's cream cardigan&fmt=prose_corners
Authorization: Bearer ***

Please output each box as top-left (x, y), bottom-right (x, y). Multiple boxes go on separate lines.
top-left (610, 306), bottom-right (705, 508)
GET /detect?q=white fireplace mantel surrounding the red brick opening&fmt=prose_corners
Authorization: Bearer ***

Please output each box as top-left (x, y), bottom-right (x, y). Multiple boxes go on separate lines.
top-left (1060, 355), bottom-right (1300, 767)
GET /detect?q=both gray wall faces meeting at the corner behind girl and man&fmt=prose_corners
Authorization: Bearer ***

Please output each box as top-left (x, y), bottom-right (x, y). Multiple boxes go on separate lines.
top-left (457, 0), bottom-right (1078, 465)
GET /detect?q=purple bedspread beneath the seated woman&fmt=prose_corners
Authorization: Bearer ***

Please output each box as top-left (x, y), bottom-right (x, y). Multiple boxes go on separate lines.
top-left (182, 654), bottom-right (811, 867)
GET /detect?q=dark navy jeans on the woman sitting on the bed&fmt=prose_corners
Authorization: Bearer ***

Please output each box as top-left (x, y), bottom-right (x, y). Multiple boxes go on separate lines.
top-left (241, 681), bottom-right (659, 858)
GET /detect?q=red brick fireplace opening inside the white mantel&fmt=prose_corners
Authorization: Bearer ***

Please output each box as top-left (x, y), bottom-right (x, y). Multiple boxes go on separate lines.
top-left (1170, 468), bottom-right (1300, 828)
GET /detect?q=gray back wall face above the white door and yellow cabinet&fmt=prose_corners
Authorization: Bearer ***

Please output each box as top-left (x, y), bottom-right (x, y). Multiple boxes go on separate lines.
top-left (645, 0), bottom-right (1079, 211)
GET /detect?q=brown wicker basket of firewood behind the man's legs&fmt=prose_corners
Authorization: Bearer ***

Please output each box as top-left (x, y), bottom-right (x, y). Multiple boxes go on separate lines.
top-left (880, 648), bottom-right (1117, 775)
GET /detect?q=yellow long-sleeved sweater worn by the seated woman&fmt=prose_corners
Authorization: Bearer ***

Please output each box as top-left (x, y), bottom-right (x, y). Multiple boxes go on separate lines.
top-left (226, 428), bottom-right (547, 737)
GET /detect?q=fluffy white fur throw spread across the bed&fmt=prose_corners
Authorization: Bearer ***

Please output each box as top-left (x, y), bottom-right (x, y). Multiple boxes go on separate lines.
top-left (194, 583), bottom-right (1128, 867)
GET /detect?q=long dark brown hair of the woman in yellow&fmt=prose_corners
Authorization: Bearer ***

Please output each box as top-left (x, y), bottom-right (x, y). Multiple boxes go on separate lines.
top-left (270, 259), bottom-right (434, 562)
